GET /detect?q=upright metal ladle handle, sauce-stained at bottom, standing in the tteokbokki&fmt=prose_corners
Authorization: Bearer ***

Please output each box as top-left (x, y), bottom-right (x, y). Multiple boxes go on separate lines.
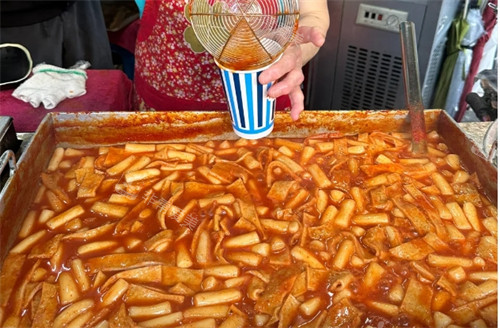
top-left (399, 22), bottom-right (427, 154)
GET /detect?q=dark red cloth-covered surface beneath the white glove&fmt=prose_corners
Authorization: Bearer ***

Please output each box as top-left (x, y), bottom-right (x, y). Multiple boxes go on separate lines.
top-left (0, 69), bottom-right (132, 132)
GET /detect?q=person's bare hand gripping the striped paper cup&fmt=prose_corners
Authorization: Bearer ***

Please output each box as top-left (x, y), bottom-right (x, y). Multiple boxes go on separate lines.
top-left (259, 26), bottom-right (325, 121)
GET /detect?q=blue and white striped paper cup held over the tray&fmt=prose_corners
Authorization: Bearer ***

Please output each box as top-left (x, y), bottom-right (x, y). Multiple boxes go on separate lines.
top-left (215, 61), bottom-right (276, 139)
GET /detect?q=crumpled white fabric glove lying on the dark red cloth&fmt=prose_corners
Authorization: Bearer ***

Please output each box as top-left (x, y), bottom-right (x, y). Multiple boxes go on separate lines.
top-left (12, 62), bottom-right (89, 109)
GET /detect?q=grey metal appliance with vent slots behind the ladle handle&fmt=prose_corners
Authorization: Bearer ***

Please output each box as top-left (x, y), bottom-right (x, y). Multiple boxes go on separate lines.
top-left (305, 0), bottom-right (461, 110)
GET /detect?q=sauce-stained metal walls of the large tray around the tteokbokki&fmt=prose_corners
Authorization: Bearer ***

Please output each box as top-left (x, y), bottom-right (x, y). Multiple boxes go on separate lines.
top-left (0, 110), bottom-right (498, 263)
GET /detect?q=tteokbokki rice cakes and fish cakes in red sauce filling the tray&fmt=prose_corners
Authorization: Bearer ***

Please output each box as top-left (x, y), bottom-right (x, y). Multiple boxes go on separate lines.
top-left (0, 132), bottom-right (498, 328)
